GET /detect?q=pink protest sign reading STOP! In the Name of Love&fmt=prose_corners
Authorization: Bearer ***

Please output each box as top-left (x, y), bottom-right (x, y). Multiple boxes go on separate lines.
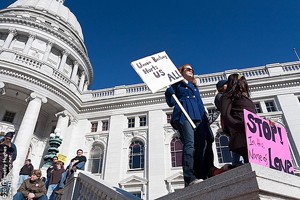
top-left (244, 109), bottom-right (294, 174)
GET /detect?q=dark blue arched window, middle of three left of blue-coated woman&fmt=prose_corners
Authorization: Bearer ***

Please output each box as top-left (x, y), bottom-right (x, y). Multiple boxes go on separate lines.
top-left (129, 141), bottom-right (144, 169)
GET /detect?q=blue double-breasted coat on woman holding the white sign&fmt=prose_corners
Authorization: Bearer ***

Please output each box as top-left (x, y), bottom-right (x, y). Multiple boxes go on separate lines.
top-left (165, 81), bottom-right (208, 129)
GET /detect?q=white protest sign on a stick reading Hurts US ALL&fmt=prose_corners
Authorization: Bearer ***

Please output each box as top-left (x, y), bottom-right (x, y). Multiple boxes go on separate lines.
top-left (131, 51), bottom-right (183, 93)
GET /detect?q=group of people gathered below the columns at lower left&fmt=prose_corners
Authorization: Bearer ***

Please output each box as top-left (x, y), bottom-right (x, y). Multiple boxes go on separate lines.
top-left (0, 148), bottom-right (87, 200)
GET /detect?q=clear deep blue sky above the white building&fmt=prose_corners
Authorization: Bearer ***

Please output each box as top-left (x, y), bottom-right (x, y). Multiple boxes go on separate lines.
top-left (0, 0), bottom-right (300, 90)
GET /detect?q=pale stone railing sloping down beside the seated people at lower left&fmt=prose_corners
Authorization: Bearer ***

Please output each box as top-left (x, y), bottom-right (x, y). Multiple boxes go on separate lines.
top-left (62, 172), bottom-right (140, 200)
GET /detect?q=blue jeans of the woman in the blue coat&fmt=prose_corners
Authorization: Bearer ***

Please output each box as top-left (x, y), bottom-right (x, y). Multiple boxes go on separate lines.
top-left (175, 120), bottom-right (196, 186)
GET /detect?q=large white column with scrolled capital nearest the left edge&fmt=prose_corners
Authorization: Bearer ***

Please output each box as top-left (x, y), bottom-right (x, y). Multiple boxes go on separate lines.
top-left (12, 92), bottom-right (47, 191)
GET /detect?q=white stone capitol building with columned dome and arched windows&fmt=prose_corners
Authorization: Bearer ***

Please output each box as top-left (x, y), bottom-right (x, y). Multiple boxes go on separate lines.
top-left (0, 0), bottom-right (300, 200)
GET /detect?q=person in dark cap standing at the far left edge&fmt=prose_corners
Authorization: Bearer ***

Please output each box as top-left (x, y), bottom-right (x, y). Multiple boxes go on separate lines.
top-left (0, 132), bottom-right (17, 180)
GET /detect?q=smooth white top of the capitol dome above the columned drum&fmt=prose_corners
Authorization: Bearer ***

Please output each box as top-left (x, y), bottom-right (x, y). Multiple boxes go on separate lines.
top-left (8, 0), bottom-right (83, 40)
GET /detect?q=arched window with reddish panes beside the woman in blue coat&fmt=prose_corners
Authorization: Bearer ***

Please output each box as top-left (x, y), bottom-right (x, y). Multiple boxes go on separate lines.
top-left (171, 137), bottom-right (183, 167)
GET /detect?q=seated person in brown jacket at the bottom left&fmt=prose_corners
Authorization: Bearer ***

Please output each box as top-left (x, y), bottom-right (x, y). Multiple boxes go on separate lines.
top-left (13, 169), bottom-right (48, 200)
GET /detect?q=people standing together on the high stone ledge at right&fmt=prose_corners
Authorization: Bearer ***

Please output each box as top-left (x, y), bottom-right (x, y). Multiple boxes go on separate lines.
top-left (165, 64), bottom-right (256, 187)
